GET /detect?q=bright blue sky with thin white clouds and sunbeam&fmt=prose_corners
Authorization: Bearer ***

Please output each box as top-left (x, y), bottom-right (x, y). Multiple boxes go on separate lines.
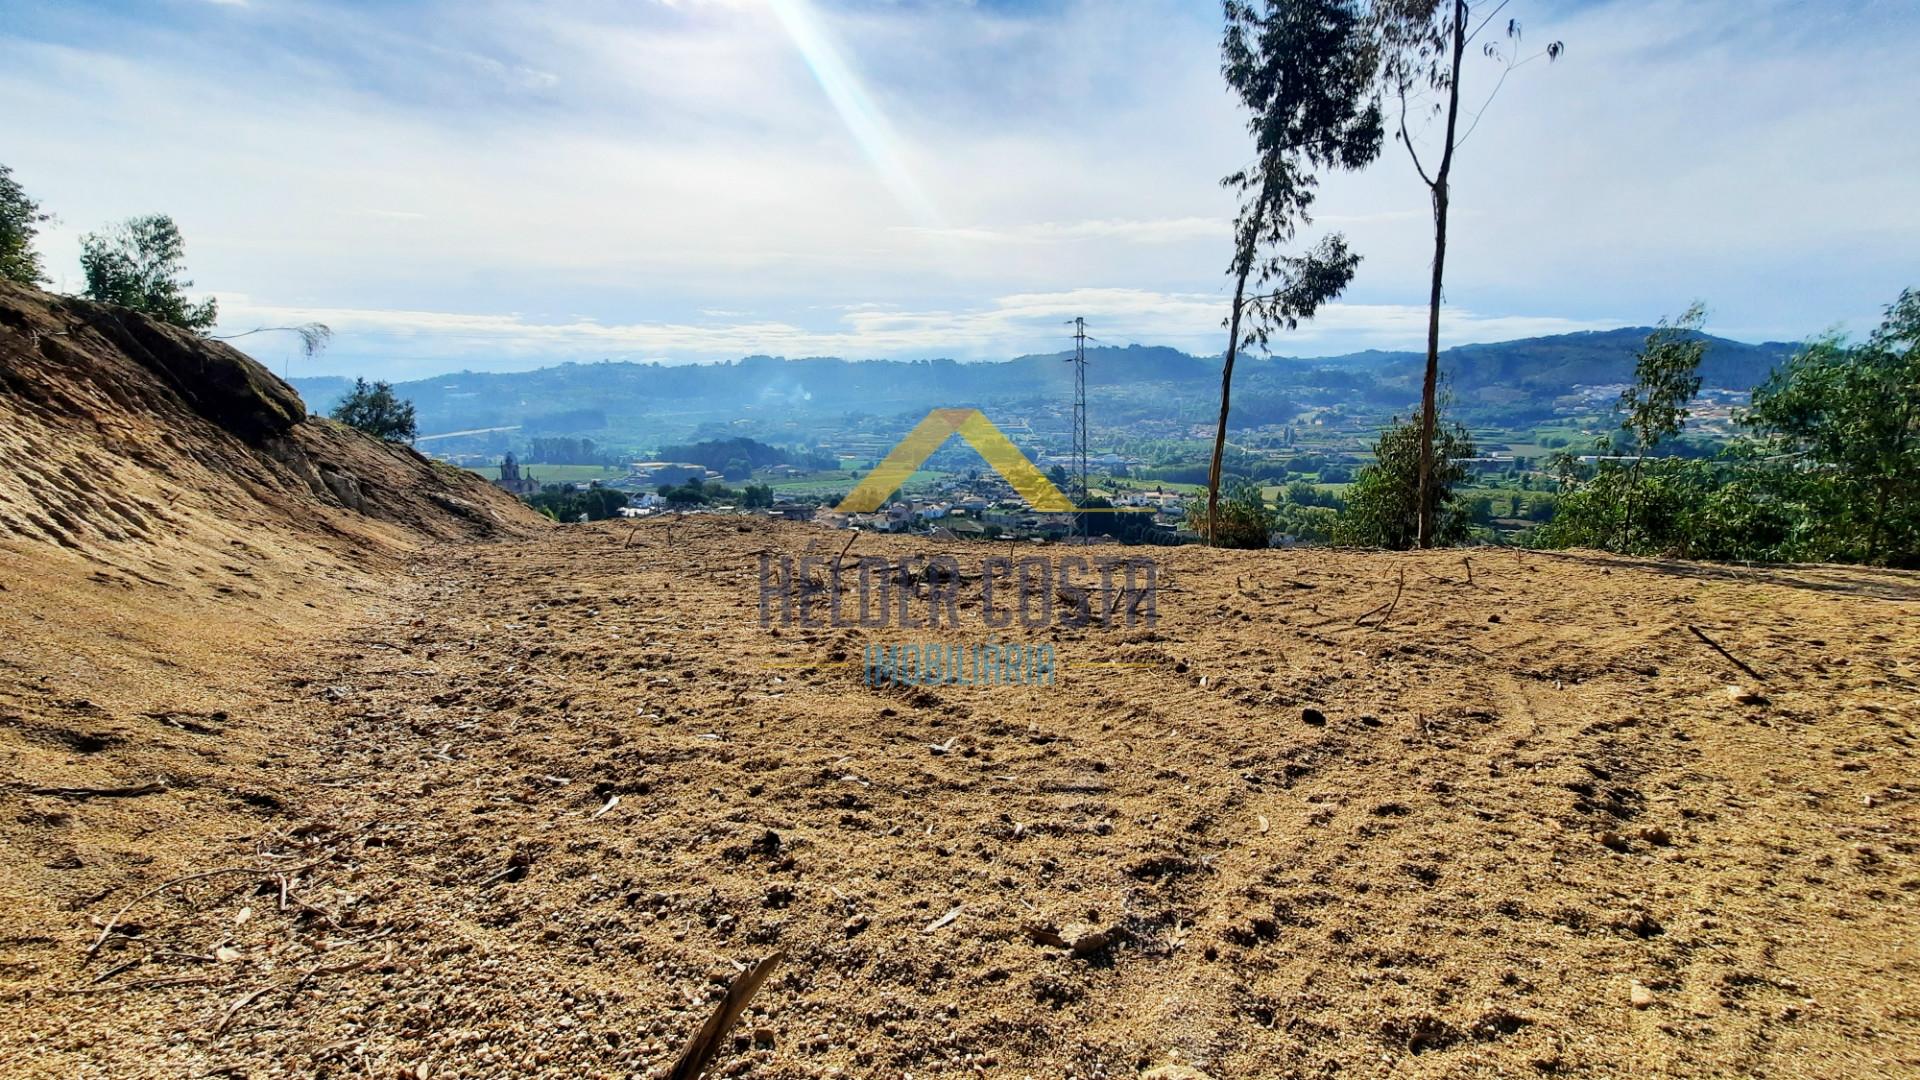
top-left (0, 0), bottom-right (1920, 379)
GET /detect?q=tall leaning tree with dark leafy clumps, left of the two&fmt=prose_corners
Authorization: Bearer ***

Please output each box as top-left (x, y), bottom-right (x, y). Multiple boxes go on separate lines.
top-left (1206, 0), bottom-right (1384, 544)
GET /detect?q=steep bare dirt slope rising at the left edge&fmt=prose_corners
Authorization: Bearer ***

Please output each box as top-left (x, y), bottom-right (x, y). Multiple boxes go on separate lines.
top-left (0, 282), bottom-right (543, 1074)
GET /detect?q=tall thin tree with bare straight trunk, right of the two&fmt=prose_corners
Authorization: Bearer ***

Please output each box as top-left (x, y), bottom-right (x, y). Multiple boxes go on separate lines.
top-left (1373, 0), bottom-right (1567, 548)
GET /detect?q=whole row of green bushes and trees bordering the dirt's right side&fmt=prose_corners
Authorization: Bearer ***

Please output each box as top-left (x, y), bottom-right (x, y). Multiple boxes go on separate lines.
top-left (1188, 290), bottom-right (1920, 567)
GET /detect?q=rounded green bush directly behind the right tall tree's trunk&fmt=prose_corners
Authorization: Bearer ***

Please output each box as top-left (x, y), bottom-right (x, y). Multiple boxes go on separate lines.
top-left (1332, 409), bottom-right (1473, 550)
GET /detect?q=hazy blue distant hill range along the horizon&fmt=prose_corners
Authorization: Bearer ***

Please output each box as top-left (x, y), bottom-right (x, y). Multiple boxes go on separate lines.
top-left (294, 327), bottom-right (1795, 444)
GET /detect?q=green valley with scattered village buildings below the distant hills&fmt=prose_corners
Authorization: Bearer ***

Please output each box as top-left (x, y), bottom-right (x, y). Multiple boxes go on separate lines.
top-left (453, 395), bottom-right (1589, 546)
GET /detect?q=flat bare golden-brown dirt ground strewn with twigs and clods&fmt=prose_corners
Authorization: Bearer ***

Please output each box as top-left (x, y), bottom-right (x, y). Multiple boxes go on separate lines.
top-left (0, 519), bottom-right (1920, 1078)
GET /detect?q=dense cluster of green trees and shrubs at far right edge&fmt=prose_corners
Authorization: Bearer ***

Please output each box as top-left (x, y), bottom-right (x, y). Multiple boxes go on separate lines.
top-left (1532, 290), bottom-right (1920, 567)
